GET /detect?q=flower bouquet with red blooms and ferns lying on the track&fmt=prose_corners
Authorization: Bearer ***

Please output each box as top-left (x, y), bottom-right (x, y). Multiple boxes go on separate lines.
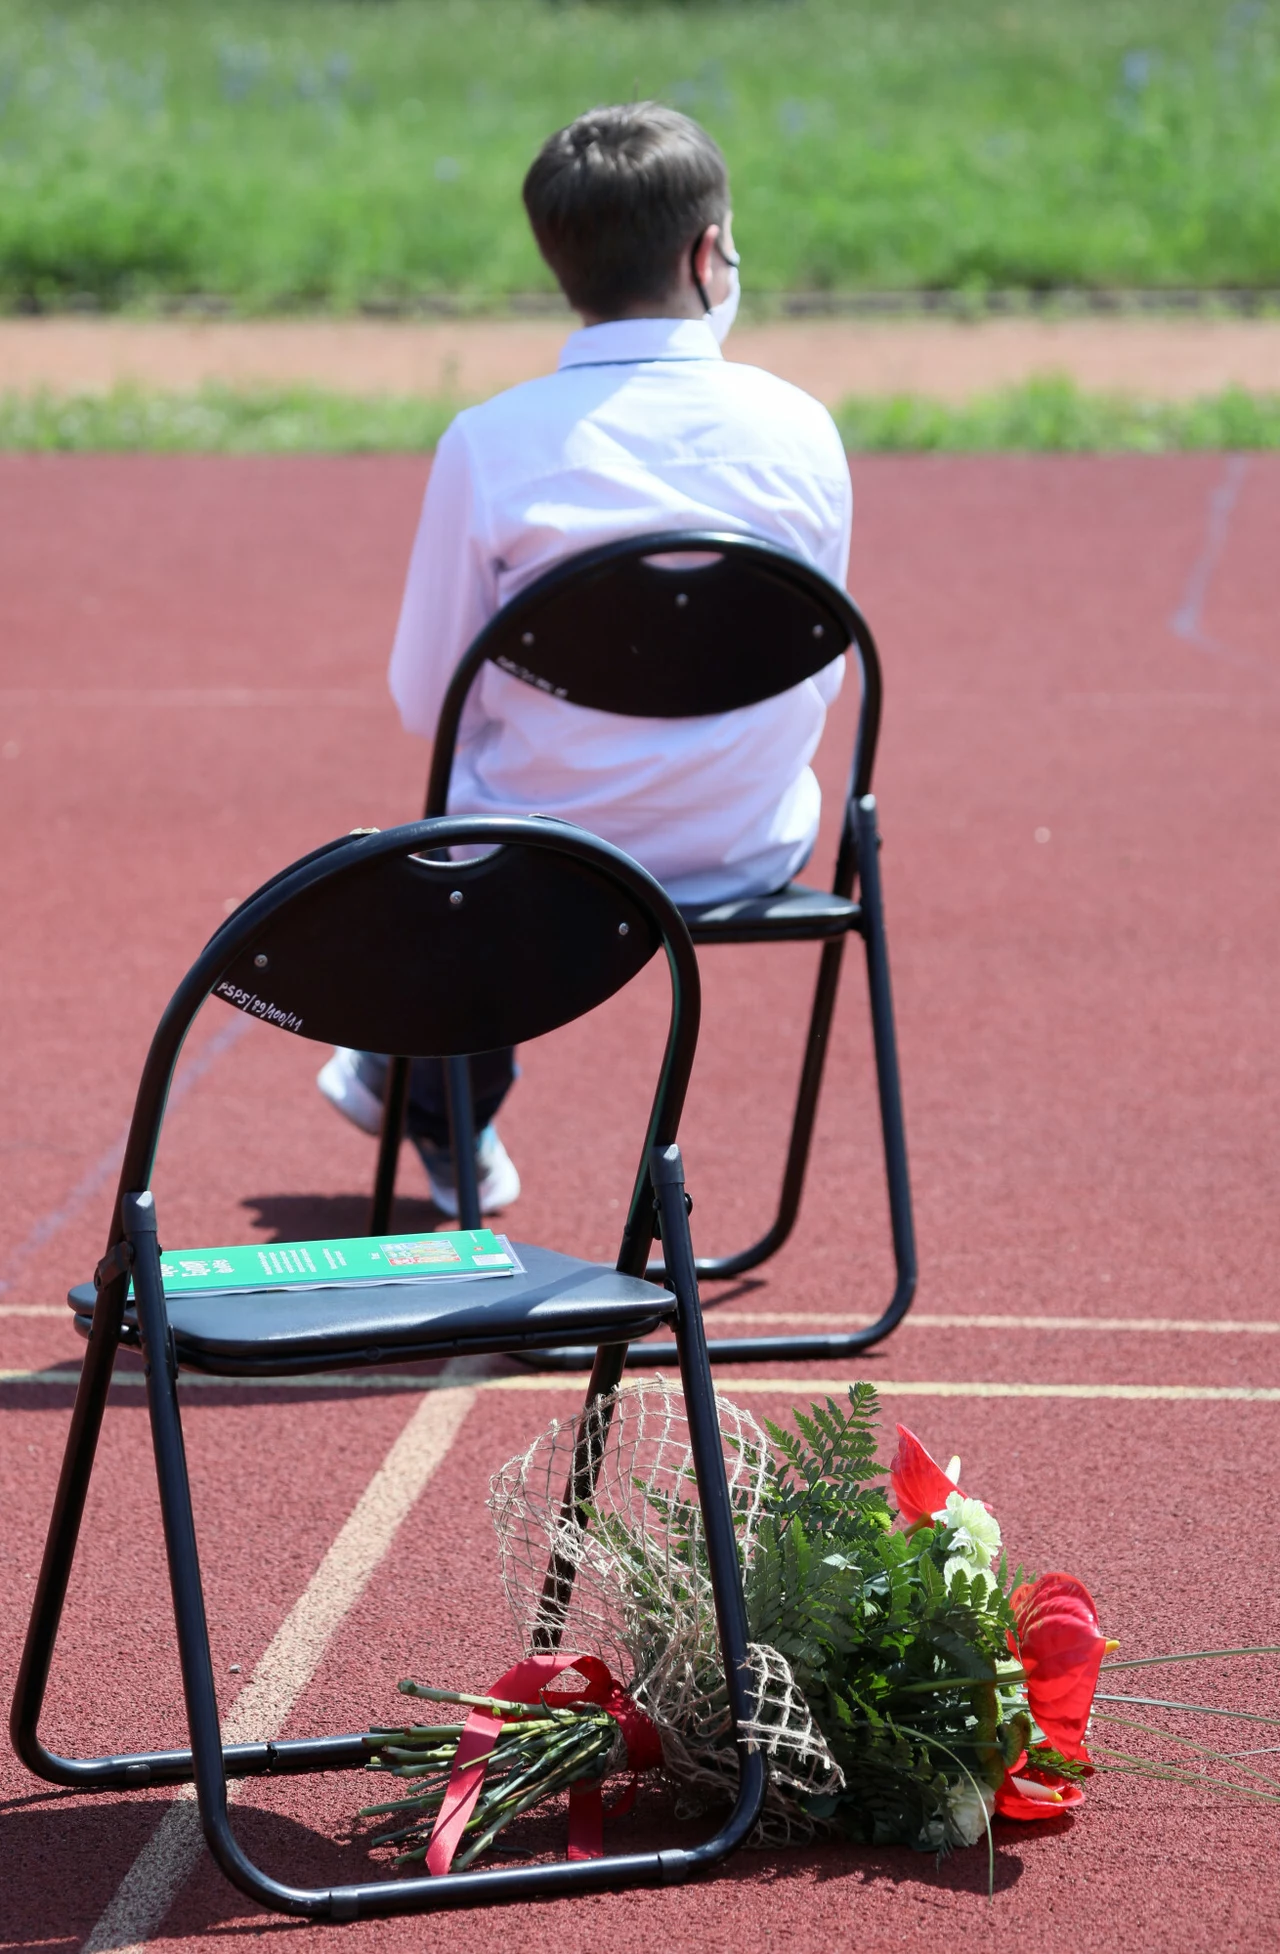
top-left (362, 1380), bottom-right (1276, 1872)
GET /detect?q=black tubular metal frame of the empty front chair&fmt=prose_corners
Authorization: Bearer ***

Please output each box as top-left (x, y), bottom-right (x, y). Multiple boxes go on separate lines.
top-left (10, 819), bottom-right (766, 1921)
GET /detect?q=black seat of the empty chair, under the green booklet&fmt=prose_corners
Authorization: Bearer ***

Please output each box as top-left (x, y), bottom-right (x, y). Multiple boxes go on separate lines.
top-left (66, 1243), bottom-right (676, 1376)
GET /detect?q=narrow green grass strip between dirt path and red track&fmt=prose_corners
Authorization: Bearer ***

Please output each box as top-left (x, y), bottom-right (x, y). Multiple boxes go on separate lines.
top-left (0, 379), bottom-right (1280, 455)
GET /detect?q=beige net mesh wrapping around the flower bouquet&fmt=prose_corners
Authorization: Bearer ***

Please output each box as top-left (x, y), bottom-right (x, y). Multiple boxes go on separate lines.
top-left (489, 1378), bottom-right (844, 1841)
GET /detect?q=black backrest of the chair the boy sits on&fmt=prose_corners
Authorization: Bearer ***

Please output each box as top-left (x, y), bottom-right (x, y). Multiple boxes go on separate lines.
top-left (426, 531), bottom-right (881, 815)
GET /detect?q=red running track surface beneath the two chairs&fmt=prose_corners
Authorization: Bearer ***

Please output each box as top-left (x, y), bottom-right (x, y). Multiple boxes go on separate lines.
top-left (0, 455), bottom-right (1280, 1954)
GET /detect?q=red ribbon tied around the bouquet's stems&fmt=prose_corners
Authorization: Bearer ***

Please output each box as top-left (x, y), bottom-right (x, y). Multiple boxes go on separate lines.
top-left (426, 1655), bottom-right (662, 1874)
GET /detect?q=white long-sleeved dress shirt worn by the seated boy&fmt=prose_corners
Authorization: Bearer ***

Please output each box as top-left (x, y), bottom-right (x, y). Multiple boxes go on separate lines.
top-left (389, 319), bottom-right (852, 903)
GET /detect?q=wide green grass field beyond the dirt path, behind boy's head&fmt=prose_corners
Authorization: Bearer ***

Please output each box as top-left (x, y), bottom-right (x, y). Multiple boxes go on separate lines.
top-left (0, 0), bottom-right (1280, 311)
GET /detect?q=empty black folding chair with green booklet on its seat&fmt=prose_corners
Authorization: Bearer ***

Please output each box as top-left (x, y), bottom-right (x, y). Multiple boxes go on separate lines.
top-left (12, 819), bottom-right (764, 1921)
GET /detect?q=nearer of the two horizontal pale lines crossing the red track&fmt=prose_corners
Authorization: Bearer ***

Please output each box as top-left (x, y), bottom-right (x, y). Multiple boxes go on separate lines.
top-left (12, 1370), bottom-right (1280, 1405)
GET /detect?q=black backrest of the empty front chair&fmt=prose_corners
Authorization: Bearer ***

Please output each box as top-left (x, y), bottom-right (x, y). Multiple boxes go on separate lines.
top-left (113, 815), bottom-right (700, 1274)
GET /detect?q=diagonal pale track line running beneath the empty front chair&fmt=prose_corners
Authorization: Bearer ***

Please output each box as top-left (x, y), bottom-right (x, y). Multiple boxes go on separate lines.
top-left (82, 1366), bottom-right (475, 1954)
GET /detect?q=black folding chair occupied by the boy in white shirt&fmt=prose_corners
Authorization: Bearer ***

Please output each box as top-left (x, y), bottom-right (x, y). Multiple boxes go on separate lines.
top-left (369, 531), bottom-right (917, 1366)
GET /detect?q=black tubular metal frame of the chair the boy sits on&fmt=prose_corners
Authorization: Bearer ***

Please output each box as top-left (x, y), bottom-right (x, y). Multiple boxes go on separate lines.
top-left (369, 530), bottom-right (918, 1368)
